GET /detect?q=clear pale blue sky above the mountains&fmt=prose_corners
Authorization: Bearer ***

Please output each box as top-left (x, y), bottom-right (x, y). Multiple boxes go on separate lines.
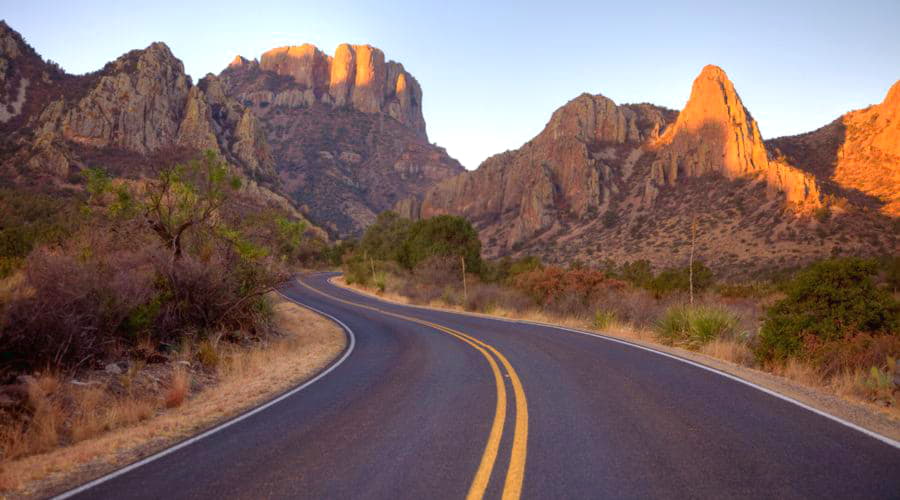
top-left (0, 0), bottom-right (900, 168)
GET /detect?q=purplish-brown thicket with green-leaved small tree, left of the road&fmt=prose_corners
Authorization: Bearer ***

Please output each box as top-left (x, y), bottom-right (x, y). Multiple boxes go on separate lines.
top-left (0, 155), bottom-right (292, 378)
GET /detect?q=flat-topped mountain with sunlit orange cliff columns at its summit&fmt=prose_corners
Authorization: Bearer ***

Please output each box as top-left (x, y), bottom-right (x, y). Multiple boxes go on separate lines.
top-left (220, 44), bottom-right (464, 237)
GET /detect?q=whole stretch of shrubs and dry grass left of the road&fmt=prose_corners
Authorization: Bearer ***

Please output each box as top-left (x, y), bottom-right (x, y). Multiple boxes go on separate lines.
top-left (0, 152), bottom-right (322, 468)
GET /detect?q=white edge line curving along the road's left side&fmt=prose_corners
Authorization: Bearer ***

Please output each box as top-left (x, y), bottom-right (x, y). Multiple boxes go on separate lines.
top-left (53, 291), bottom-right (356, 500)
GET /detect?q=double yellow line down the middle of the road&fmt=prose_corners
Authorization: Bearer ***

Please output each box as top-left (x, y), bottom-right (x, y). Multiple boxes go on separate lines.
top-left (297, 279), bottom-right (528, 500)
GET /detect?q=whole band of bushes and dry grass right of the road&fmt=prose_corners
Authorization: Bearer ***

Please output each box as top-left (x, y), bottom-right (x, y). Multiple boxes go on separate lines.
top-left (340, 212), bottom-right (900, 415)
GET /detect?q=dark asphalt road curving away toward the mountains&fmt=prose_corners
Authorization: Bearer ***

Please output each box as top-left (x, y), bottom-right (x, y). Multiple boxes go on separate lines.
top-left (63, 274), bottom-right (900, 499)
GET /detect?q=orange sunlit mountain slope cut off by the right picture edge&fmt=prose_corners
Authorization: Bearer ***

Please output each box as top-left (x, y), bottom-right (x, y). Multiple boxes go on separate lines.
top-left (767, 81), bottom-right (900, 217)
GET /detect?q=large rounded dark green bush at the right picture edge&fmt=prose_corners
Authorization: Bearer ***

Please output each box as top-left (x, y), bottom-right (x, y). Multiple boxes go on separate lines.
top-left (755, 258), bottom-right (900, 361)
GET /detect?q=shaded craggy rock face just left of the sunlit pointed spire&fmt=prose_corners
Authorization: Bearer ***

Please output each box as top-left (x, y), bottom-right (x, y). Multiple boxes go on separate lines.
top-left (397, 94), bottom-right (674, 246)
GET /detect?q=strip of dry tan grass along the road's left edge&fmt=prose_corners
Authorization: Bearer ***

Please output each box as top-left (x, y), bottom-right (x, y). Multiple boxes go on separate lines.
top-left (0, 298), bottom-right (346, 496)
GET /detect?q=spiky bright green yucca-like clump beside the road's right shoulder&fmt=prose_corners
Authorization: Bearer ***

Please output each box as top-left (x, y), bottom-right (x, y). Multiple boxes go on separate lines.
top-left (656, 306), bottom-right (738, 349)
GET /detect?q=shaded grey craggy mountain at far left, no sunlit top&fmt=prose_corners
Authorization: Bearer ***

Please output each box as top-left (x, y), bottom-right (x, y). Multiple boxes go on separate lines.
top-left (0, 21), bottom-right (314, 223)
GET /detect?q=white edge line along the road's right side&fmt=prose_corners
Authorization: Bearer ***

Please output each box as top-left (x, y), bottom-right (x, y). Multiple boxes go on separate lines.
top-left (328, 277), bottom-right (900, 450)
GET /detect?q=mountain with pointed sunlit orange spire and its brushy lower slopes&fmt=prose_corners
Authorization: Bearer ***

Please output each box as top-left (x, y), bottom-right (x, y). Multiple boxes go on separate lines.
top-left (395, 66), bottom-right (898, 273)
